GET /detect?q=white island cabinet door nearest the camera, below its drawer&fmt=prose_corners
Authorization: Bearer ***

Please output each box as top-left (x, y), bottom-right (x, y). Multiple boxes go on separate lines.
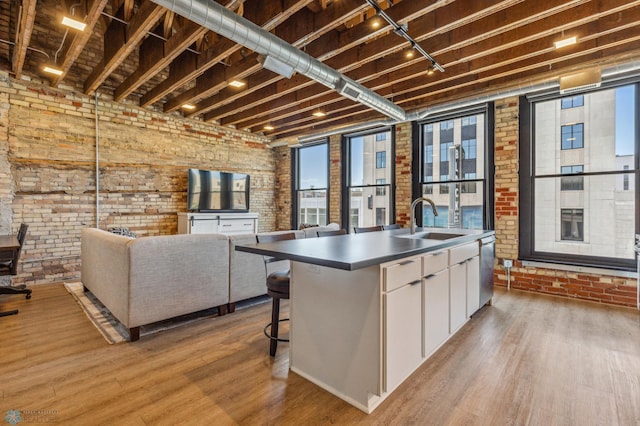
top-left (384, 280), bottom-right (422, 392)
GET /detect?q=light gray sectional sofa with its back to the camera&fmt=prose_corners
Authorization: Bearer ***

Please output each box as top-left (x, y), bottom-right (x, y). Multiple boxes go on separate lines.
top-left (80, 224), bottom-right (338, 341)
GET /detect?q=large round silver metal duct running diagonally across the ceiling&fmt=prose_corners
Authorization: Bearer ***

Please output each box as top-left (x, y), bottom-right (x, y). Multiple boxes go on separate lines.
top-left (152, 0), bottom-right (406, 121)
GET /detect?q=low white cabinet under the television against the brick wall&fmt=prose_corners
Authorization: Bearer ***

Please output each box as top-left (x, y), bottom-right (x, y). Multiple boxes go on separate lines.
top-left (178, 213), bottom-right (258, 234)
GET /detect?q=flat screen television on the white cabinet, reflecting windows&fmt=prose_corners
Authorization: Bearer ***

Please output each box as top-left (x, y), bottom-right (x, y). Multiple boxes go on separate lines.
top-left (187, 169), bottom-right (250, 212)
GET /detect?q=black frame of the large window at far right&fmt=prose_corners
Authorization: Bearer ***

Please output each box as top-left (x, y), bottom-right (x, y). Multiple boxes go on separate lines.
top-left (518, 81), bottom-right (640, 271)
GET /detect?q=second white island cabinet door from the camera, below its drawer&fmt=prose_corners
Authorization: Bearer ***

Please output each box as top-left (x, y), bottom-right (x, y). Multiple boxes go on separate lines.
top-left (423, 269), bottom-right (449, 357)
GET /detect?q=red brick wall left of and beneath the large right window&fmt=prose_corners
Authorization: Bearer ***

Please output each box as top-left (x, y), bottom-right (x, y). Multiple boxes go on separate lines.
top-left (494, 97), bottom-right (637, 306)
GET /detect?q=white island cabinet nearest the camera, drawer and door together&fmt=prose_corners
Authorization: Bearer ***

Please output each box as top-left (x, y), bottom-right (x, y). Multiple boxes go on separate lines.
top-left (382, 257), bottom-right (422, 392)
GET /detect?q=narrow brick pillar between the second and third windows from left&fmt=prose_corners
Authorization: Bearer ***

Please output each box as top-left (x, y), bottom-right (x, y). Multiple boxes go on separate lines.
top-left (395, 123), bottom-right (413, 228)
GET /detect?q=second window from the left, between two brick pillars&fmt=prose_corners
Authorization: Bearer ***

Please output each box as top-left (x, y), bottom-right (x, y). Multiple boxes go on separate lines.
top-left (342, 130), bottom-right (395, 230)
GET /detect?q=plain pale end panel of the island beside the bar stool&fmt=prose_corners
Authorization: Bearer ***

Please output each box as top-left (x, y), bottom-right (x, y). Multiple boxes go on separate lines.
top-left (289, 262), bottom-right (382, 413)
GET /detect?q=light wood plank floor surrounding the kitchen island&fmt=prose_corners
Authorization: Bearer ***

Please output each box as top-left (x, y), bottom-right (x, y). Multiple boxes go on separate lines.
top-left (0, 285), bottom-right (640, 426)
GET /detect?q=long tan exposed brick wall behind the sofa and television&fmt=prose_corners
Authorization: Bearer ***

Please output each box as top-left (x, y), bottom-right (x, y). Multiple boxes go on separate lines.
top-left (0, 74), bottom-right (276, 284)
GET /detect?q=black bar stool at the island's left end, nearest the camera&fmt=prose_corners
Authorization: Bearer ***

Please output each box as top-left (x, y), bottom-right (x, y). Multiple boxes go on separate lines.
top-left (256, 232), bottom-right (296, 356)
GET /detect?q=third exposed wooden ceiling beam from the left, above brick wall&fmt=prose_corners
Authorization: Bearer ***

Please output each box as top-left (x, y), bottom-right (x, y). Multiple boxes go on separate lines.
top-left (84, 0), bottom-right (166, 95)
